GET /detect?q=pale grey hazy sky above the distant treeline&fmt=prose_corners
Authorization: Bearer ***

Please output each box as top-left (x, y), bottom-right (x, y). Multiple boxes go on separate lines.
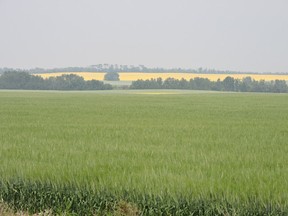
top-left (0, 0), bottom-right (288, 72)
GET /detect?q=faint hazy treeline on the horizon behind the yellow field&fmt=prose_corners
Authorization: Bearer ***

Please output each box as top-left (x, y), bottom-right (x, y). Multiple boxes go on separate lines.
top-left (0, 64), bottom-right (287, 74)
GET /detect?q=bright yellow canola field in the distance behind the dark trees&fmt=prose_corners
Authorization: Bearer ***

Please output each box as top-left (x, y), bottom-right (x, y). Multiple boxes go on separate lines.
top-left (36, 72), bottom-right (288, 81)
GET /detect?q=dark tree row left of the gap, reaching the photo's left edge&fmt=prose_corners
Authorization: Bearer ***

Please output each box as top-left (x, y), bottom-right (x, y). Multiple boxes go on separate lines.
top-left (0, 71), bottom-right (112, 90)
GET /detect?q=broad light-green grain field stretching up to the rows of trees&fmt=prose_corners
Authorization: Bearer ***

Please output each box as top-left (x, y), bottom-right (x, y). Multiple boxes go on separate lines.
top-left (0, 90), bottom-right (288, 215)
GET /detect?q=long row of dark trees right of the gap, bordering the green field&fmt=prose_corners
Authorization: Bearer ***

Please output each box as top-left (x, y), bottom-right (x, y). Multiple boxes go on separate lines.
top-left (130, 76), bottom-right (288, 93)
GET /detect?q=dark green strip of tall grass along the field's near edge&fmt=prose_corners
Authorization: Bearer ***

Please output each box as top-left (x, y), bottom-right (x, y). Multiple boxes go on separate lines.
top-left (0, 180), bottom-right (288, 215)
